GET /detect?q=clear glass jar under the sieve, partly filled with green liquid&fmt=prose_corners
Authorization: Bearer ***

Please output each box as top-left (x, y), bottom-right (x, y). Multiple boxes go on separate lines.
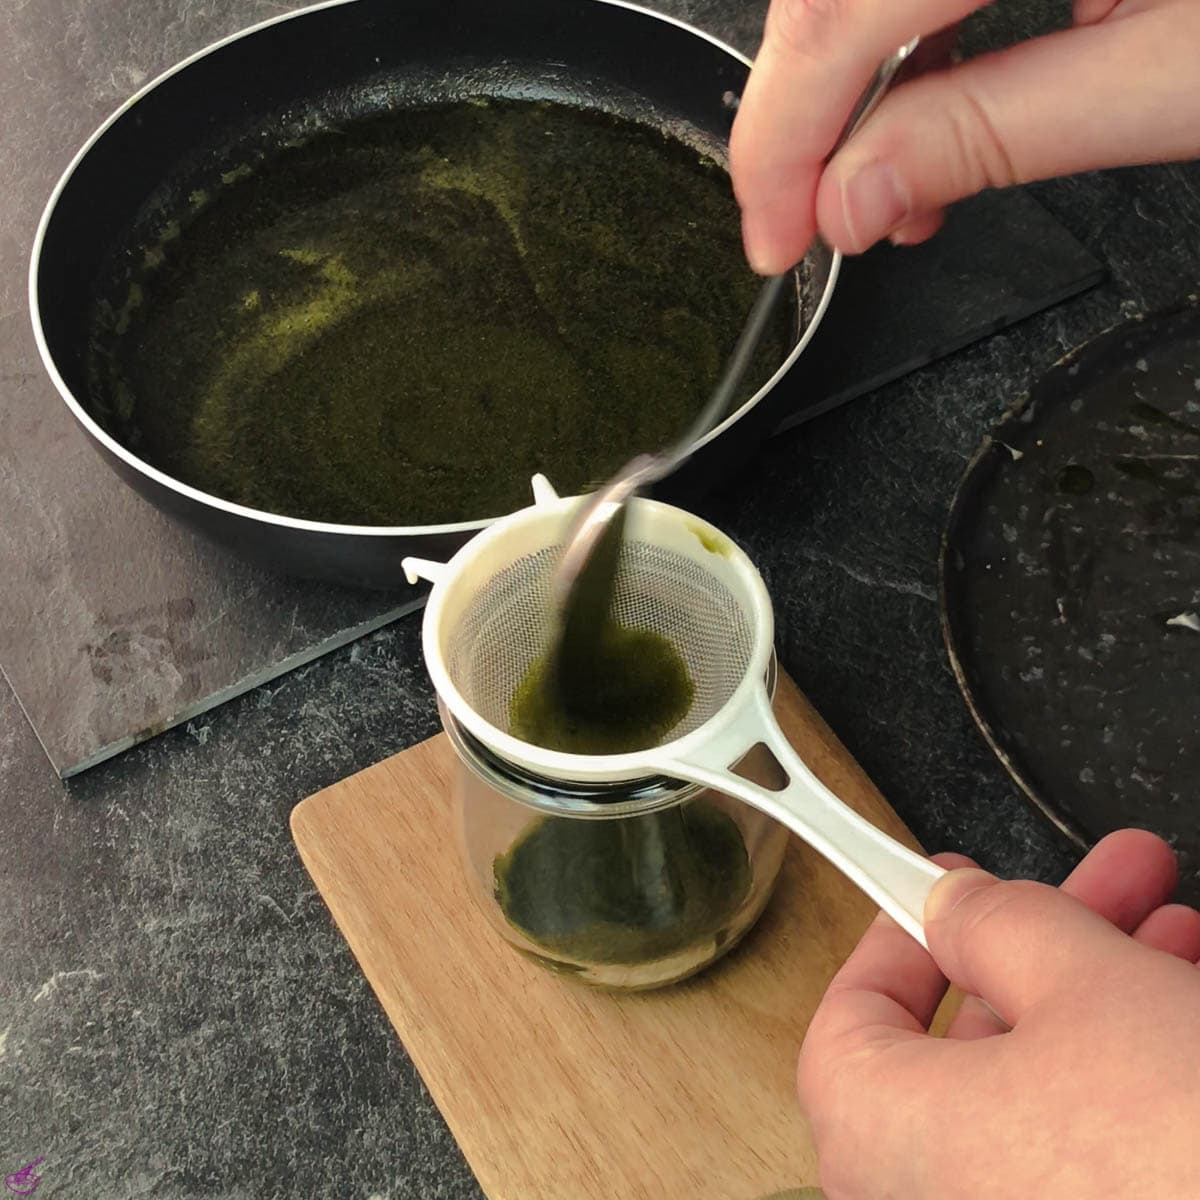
top-left (439, 664), bottom-right (788, 990)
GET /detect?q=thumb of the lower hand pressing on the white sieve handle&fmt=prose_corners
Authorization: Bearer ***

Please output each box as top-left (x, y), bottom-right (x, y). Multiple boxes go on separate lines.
top-left (925, 868), bottom-right (1142, 1025)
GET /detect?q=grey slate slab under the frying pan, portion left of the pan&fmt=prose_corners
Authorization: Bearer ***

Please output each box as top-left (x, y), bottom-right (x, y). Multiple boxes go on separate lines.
top-left (0, 0), bottom-right (427, 774)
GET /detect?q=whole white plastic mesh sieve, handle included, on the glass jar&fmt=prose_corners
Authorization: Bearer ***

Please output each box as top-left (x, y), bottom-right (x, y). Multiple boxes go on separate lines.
top-left (404, 476), bottom-right (943, 943)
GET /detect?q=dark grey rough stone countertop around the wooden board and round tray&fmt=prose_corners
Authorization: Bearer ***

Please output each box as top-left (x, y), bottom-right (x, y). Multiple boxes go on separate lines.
top-left (0, 0), bottom-right (1200, 1200)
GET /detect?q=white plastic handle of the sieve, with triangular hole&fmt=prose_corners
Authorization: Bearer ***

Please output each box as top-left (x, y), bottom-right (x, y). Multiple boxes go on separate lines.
top-left (647, 688), bottom-right (946, 946)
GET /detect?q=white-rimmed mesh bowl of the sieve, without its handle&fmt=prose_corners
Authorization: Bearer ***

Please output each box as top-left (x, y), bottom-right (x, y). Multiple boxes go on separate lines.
top-left (406, 468), bottom-right (774, 782)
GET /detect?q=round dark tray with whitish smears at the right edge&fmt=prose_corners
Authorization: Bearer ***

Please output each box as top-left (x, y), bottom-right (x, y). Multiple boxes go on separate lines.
top-left (942, 306), bottom-right (1200, 902)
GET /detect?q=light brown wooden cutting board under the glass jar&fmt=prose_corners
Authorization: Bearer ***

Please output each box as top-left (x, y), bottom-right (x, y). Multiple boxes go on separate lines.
top-left (292, 677), bottom-right (916, 1200)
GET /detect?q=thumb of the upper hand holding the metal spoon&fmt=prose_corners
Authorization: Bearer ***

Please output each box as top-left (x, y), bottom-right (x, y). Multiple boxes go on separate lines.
top-left (816, 5), bottom-right (1200, 253)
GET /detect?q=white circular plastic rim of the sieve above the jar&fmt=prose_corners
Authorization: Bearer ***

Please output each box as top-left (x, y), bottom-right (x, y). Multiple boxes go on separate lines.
top-left (421, 496), bottom-right (775, 782)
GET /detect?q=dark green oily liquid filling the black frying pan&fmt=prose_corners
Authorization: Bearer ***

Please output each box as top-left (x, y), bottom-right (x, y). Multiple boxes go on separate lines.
top-left (90, 93), bottom-right (796, 524)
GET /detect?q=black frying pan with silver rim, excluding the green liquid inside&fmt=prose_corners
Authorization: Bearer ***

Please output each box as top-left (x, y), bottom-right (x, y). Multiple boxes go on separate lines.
top-left (30, 0), bottom-right (839, 588)
